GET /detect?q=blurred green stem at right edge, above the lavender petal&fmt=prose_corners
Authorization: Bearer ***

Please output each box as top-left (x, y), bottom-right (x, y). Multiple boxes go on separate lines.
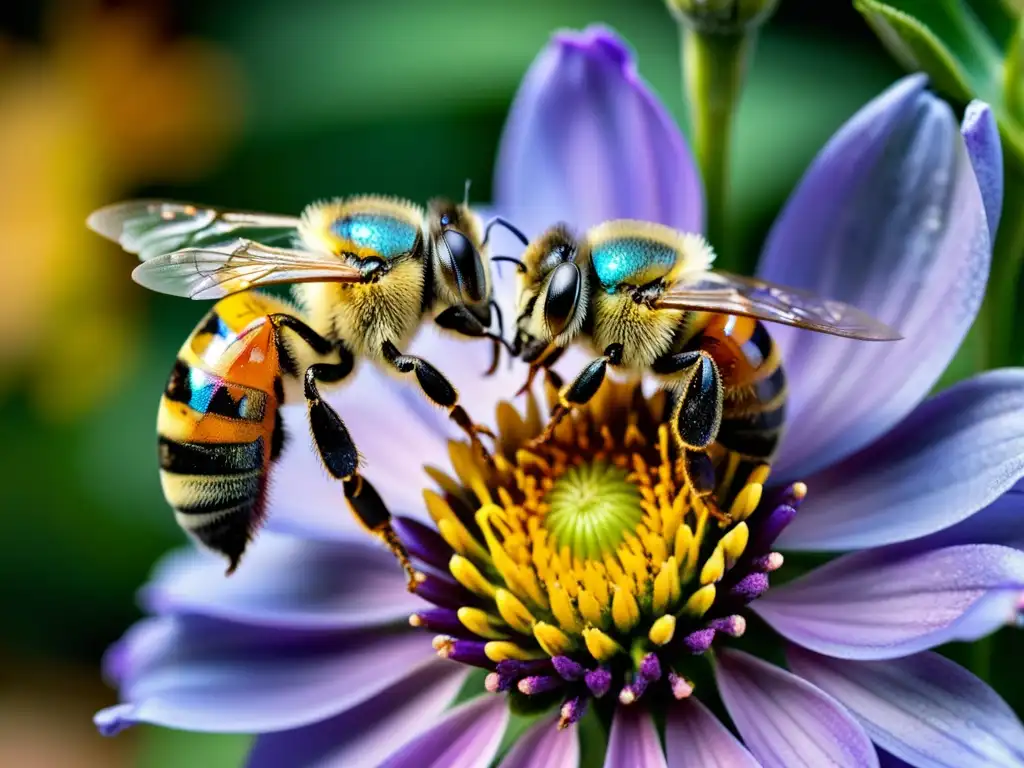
top-left (980, 153), bottom-right (1024, 368)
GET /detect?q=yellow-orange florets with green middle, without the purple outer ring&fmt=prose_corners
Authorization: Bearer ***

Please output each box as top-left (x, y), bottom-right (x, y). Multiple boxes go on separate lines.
top-left (419, 382), bottom-right (768, 675)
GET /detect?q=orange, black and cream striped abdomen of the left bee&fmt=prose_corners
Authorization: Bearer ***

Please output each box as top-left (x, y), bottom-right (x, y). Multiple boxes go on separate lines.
top-left (157, 297), bottom-right (284, 572)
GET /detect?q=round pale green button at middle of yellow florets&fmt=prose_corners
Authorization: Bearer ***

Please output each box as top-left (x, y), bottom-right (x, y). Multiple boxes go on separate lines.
top-left (544, 461), bottom-right (643, 560)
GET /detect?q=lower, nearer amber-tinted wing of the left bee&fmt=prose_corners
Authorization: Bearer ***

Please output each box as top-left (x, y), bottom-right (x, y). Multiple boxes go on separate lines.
top-left (132, 240), bottom-right (361, 299)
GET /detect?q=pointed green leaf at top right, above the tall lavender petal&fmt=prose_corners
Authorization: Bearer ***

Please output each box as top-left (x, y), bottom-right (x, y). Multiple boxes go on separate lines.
top-left (854, 0), bottom-right (972, 101)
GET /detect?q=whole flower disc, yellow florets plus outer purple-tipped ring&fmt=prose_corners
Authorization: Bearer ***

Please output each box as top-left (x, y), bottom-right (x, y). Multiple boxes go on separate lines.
top-left (399, 382), bottom-right (803, 725)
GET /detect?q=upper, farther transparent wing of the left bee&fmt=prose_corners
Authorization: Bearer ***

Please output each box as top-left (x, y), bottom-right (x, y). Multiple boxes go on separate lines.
top-left (86, 200), bottom-right (299, 261)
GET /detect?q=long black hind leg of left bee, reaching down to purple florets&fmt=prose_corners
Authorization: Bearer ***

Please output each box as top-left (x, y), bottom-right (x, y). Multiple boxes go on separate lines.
top-left (304, 350), bottom-right (414, 590)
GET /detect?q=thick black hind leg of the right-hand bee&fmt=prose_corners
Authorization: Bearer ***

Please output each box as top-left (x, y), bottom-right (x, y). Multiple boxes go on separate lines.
top-left (652, 351), bottom-right (729, 522)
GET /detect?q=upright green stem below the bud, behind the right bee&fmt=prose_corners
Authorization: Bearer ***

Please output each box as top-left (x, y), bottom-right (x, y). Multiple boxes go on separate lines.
top-left (681, 25), bottom-right (756, 268)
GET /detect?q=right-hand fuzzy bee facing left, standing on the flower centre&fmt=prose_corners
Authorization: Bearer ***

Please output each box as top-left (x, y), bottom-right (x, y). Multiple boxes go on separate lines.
top-left (513, 220), bottom-right (901, 521)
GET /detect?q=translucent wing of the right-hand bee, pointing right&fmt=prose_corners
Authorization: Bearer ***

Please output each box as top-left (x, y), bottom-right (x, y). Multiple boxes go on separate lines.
top-left (654, 271), bottom-right (903, 341)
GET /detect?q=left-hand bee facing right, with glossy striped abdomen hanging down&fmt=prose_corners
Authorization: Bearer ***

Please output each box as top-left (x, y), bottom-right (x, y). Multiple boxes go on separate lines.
top-left (88, 188), bottom-right (528, 578)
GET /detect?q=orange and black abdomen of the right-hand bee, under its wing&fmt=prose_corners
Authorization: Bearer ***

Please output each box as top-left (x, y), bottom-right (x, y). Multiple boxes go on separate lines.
top-left (691, 315), bottom-right (786, 501)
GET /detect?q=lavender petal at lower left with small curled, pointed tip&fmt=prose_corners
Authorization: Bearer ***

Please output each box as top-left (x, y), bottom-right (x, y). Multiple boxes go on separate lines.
top-left (96, 615), bottom-right (447, 733)
